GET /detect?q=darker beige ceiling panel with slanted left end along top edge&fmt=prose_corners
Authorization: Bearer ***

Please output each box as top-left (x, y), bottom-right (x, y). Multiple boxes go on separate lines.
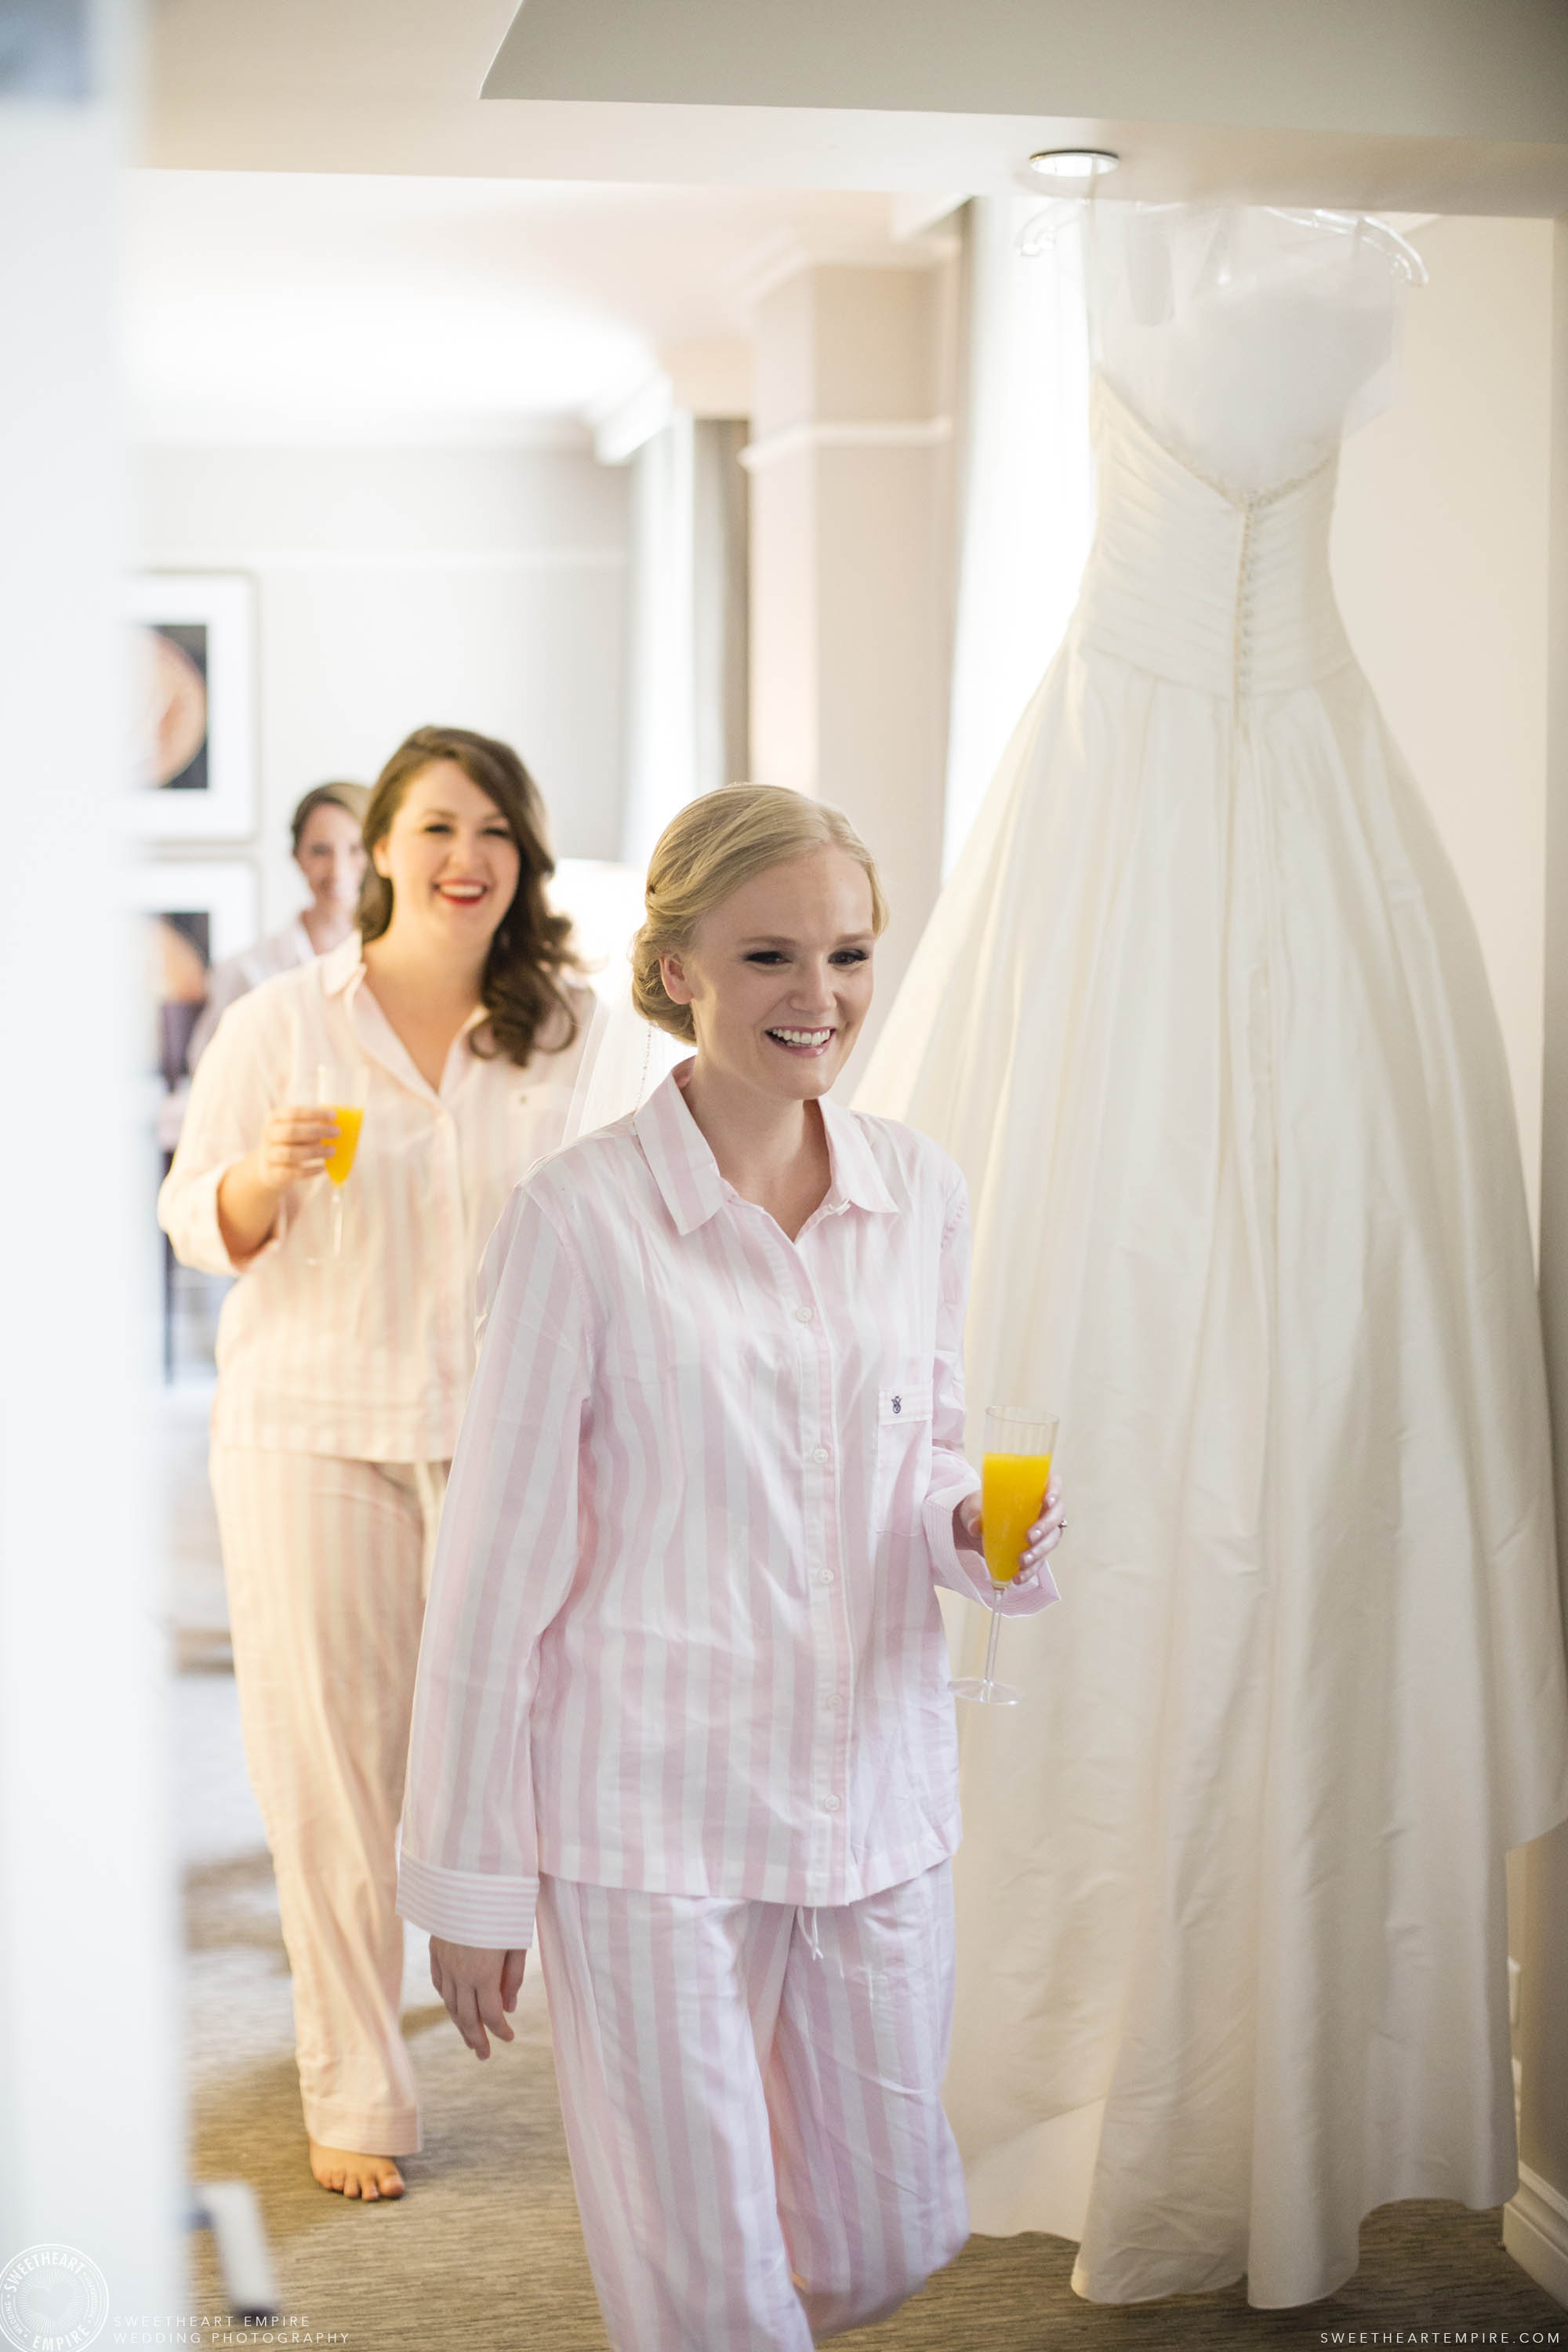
top-left (485, 0), bottom-right (1568, 143)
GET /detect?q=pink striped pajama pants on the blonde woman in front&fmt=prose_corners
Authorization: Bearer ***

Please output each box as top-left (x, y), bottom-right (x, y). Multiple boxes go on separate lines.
top-left (539, 1863), bottom-right (968, 2352)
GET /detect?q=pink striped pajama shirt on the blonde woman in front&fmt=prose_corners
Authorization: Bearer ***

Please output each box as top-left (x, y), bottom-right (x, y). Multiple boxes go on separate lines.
top-left (400, 1063), bottom-right (1055, 1947)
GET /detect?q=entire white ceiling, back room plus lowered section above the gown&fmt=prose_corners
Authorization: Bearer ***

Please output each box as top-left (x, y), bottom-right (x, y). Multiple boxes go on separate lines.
top-left (138, 0), bottom-right (1568, 442)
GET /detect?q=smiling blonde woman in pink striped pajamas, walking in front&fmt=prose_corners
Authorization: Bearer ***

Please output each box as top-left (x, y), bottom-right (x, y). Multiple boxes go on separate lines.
top-left (400, 786), bottom-right (1060, 2352)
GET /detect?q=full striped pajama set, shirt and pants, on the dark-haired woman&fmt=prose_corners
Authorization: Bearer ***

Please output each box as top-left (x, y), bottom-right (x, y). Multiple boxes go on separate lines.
top-left (158, 934), bottom-right (602, 2157)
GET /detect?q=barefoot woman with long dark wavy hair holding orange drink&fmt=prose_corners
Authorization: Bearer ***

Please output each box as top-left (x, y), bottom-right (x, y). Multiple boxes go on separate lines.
top-left (160, 727), bottom-right (597, 2199)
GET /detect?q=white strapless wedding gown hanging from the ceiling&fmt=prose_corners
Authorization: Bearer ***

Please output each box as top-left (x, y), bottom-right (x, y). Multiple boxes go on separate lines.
top-left (855, 207), bottom-right (1568, 2305)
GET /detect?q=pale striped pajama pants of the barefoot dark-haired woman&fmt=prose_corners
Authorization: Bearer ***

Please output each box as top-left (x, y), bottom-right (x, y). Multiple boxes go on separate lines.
top-left (212, 1446), bottom-right (447, 2157)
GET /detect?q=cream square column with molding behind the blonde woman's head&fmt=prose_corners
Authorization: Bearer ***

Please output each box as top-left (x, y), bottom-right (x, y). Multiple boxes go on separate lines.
top-left (746, 263), bottom-right (954, 1058)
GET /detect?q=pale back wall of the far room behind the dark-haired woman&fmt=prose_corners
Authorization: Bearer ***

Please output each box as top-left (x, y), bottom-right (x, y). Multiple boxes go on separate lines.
top-left (139, 447), bottom-right (628, 929)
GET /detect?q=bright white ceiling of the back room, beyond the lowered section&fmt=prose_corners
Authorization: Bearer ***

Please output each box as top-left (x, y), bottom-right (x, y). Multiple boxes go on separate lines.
top-left (125, 169), bottom-right (931, 442)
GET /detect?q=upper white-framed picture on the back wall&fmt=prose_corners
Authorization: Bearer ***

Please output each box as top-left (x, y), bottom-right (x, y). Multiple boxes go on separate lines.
top-left (127, 572), bottom-right (256, 842)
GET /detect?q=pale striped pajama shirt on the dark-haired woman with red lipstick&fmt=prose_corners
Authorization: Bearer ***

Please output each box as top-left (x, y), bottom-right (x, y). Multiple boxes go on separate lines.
top-left (158, 931), bottom-right (602, 1461)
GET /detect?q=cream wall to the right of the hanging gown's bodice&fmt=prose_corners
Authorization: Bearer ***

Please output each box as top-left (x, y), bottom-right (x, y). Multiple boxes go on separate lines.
top-left (1333, 219), bottom-right (1552, 1223)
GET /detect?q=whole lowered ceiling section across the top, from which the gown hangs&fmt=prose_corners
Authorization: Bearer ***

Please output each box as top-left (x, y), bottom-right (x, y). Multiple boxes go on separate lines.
top-left (146, 0), bottom-right (1568, 214)
